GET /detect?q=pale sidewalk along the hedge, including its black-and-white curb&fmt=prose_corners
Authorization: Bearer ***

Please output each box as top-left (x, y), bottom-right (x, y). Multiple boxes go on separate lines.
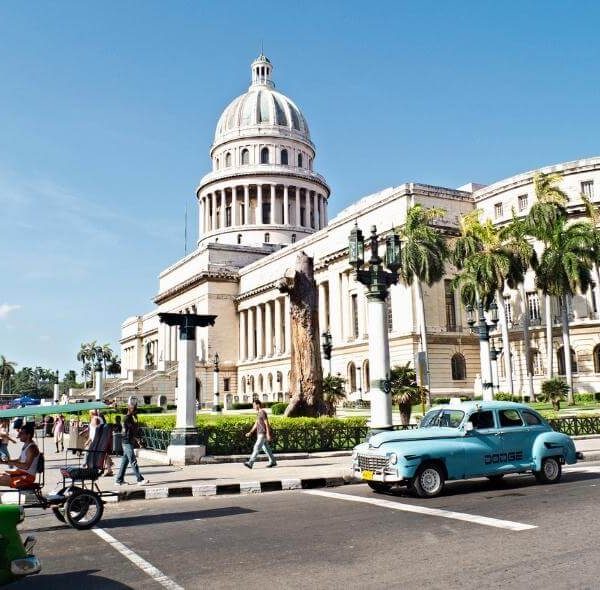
top-left (3, 435), bottom-right (600, 501)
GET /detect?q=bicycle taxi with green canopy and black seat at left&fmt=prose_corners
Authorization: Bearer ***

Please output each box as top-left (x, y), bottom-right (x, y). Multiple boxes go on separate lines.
top-left (0, 402), bottom-right (116, 530)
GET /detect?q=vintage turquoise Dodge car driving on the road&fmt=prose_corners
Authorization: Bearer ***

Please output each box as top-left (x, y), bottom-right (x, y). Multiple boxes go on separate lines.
top-left (352, 402), bottom-right (582, 498)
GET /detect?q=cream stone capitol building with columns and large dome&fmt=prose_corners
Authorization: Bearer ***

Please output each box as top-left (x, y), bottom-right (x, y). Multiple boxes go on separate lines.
top-left (112, 55), bottom-right (600, 405)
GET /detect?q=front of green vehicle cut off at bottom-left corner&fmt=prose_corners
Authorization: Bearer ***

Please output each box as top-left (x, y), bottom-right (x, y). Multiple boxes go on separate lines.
top-left (0, 504), bottom-right (42, 585)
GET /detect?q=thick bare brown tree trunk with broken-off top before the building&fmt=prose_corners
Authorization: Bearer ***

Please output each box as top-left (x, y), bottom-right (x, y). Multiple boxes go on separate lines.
top-left (279, 252), bottom-right (327, 417)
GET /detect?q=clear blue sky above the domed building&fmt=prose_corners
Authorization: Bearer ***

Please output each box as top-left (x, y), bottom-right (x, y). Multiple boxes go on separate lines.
top-left (0, 0), bottom-right (600, 371)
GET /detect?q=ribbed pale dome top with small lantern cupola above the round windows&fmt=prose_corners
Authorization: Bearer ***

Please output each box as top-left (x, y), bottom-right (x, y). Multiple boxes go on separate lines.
top-left (214, 54), bottom-right (310, 145)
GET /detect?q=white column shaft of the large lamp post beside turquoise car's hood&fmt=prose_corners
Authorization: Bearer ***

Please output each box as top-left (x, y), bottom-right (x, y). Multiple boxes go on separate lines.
top-left (367, 296), bottom-right (392, 430)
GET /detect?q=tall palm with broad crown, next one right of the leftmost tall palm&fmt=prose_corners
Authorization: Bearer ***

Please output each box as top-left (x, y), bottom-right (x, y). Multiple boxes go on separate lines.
top-left (453, 212), bottom-right (527, 395)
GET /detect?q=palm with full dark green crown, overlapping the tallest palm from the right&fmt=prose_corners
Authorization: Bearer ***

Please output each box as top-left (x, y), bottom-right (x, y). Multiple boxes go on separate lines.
top-left (536, 215), bottom-right (594, 404)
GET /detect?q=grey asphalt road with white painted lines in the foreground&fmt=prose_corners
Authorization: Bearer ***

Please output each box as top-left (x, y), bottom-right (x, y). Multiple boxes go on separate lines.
top-left (11, 463), bottom-right (600, 590)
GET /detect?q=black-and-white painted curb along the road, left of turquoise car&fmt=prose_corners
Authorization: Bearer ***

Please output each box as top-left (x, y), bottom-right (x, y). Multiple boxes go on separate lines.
top-left (115, 476), bottom-right (360, 502)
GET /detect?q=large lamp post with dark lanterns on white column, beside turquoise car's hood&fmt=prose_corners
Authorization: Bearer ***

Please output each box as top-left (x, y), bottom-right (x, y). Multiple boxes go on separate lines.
top-left (348, 223), bottom-right (400, 433)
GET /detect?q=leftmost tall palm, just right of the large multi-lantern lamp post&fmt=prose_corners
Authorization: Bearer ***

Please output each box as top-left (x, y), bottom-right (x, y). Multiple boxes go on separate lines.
top-left (400, 203), bottom-right (448, 404)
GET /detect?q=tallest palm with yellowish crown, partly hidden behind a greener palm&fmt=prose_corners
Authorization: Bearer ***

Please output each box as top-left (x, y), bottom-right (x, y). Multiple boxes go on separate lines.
top-left (527, 172), bottom-right (569, 379)
